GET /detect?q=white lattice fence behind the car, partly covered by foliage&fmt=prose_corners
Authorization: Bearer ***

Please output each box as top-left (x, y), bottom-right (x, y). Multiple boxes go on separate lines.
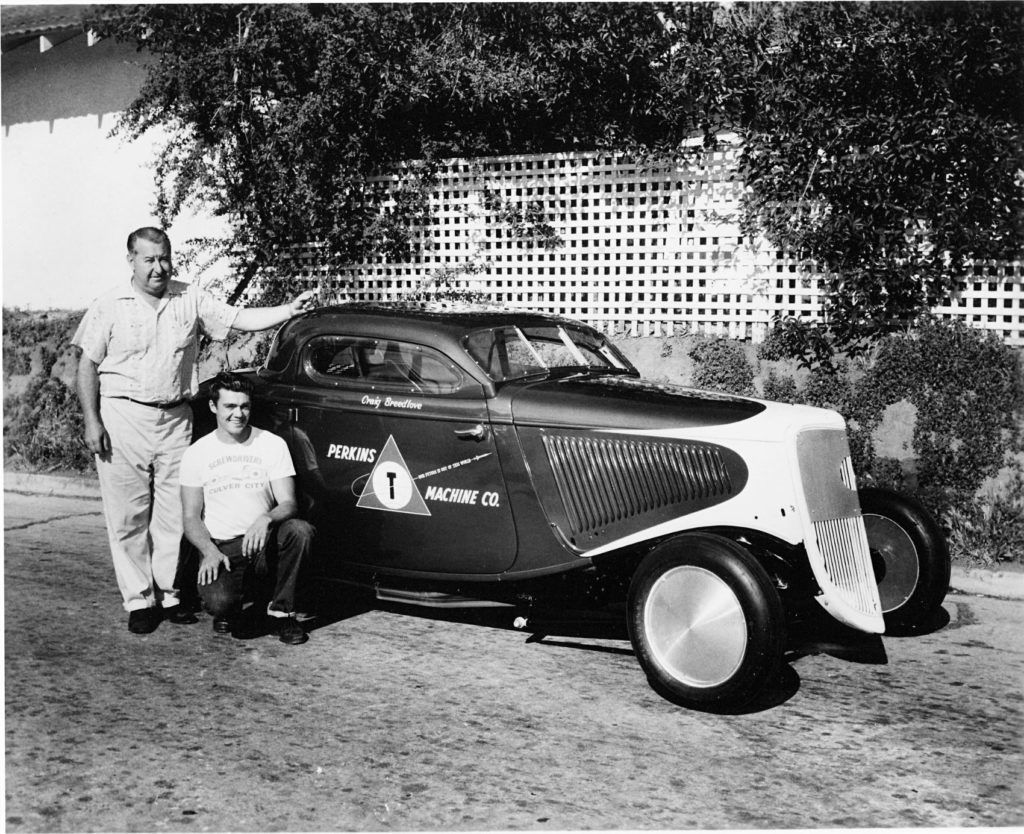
top-left (270, 150), bottom-right (1024, 344)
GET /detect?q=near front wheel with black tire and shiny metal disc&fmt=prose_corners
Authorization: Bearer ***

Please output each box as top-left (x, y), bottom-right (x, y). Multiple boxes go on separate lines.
top-left (629, 534), bottom-right (785, 709)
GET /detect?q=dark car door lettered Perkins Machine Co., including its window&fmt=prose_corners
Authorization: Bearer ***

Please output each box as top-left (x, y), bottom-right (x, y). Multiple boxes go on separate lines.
top-left (291, 334), bottom-right (516, 575)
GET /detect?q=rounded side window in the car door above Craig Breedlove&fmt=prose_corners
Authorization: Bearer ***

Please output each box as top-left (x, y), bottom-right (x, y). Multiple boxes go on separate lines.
top-left (303, 336), bottom-right (469, 394)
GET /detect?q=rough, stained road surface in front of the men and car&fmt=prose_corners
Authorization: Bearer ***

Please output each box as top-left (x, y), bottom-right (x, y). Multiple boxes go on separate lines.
top-left (4, 493), bottom-right (1024, 832)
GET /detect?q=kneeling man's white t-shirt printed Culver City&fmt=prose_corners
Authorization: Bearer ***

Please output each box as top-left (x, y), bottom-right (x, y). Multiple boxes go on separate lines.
top-left (179, 427), bottom-right (295, 539)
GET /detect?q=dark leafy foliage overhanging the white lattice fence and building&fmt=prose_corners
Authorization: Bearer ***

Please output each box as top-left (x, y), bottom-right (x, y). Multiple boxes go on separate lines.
top-left (92, 2), bottom-right (1024, 346)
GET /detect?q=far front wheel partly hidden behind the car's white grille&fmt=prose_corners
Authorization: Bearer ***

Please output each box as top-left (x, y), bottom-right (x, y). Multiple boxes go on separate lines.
top-left (860, 487), bottom-right (949, 634)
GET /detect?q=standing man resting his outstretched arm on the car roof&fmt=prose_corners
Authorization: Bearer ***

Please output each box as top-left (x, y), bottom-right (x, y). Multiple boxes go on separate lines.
top-left (72, 226), bottom-right (312, 634)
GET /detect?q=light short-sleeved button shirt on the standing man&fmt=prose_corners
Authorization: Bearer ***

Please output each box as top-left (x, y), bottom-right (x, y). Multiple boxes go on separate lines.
top-left (72, 281), bottom-right (239, 403)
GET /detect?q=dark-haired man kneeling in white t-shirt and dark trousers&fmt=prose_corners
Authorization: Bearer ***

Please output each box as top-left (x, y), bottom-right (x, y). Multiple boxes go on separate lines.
top-left (179, 373), bottom-right (315, 645)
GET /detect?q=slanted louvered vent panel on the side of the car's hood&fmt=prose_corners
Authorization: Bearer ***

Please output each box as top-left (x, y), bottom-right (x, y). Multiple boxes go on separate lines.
top-left (544, 434), bottom-right (733, 533)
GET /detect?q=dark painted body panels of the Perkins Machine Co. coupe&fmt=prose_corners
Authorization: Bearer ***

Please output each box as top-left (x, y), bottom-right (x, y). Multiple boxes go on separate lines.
top-left (197, 305), bottom-right (764, 583)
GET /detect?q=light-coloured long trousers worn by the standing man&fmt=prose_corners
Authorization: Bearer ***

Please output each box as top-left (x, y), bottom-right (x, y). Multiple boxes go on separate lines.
top-left (95, 397), bottom-right (191, 611)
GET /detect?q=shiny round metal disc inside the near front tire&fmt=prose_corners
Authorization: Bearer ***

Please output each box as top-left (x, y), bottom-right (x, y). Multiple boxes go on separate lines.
top-left (643, 566), bottom-right (746, 687)
